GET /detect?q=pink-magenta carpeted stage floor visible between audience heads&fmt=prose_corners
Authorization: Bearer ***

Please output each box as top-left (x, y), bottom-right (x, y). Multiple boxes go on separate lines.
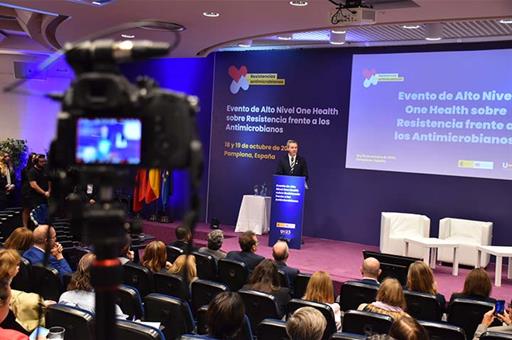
top-left (144, 221), bottom-right (512, 301)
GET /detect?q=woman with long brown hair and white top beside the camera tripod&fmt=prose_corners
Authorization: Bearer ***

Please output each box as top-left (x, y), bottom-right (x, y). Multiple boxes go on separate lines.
top-left (59, 253), bottom-right (127, 319)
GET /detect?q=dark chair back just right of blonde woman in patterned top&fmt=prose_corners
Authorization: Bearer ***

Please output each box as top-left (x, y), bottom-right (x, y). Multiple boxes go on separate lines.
top-left (404, 290), bottom-right (443, 322)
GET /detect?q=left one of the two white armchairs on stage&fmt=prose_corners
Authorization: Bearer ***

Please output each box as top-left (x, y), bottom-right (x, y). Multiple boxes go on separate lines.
top-left (380, 212), bottom-right (430, 258)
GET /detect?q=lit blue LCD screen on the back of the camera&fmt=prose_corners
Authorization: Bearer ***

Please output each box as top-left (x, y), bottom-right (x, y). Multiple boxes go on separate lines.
top-left (75, 118), bottom-right (142, 165)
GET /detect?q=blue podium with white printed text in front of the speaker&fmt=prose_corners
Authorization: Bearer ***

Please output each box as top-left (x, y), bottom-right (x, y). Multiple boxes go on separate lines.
top-left (268, 175), bottom-right (306, 249)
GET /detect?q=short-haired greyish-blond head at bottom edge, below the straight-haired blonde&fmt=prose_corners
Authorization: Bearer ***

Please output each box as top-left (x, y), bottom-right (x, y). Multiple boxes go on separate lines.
top-left (286, 307), bottom-right (327, 340)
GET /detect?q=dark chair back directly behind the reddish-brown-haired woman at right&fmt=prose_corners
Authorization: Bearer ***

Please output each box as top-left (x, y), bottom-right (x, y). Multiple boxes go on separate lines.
top-left (448, 299), bottom-right (494, 339)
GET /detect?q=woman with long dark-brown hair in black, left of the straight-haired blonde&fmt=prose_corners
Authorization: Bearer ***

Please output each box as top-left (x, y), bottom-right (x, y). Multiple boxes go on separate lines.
top-left (242, 259), bottom-right (291, 315)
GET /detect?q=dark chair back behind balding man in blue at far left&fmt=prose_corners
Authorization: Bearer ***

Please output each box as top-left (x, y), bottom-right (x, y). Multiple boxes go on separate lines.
top-left (31, 264), bottom-right (63, 301)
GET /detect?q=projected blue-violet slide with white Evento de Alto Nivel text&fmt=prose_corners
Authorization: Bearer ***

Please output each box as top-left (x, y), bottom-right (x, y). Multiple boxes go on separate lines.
top-left (346, 49), bottom-right (512, 179)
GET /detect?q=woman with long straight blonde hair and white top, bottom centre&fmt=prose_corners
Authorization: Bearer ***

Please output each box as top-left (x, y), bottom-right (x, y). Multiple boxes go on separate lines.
top-left (303, 271), bottom-right (341, 331)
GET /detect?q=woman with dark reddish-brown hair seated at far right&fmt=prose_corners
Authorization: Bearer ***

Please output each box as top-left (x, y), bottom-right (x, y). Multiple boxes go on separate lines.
top-left (450, 268), bottom-right (496, 304)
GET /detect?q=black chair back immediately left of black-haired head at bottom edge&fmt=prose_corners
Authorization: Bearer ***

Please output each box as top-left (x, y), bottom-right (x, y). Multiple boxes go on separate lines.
top-left (144, 293), bottom-right (194, 339)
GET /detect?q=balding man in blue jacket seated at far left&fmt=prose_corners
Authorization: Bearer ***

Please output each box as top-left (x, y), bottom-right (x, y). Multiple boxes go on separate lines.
top-left (23, 224), bottom-right (72, 277)
